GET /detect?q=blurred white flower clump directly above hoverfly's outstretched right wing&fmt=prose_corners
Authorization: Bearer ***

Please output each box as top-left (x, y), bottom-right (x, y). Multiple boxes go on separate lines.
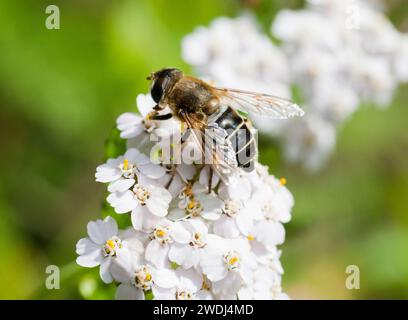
top-left (182, 15), bottom-right (290, 97)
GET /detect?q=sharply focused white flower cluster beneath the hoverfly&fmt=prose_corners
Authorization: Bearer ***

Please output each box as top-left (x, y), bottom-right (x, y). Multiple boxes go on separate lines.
top-left (77, 95), bottom-right (294, 300)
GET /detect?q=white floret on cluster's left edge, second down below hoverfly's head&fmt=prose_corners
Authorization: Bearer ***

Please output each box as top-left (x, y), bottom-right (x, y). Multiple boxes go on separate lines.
top-left (95, 148), bottom-right (166, 192)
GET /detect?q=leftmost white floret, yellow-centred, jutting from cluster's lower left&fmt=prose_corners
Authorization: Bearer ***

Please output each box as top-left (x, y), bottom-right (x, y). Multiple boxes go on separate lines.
top-left (76, 216), bottom-right (143, 283)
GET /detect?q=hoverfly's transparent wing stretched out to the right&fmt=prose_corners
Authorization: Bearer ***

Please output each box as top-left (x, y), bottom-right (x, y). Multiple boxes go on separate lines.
top-left (216, 88), bottom-right (304, 119)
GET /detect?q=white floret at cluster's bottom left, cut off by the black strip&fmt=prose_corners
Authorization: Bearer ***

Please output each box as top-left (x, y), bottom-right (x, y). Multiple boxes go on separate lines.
top-left (111, 252), bottom-right (177, 300)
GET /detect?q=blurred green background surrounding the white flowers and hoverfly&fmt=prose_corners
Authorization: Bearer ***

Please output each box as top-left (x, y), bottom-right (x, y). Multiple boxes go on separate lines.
top-left (0, 0), bottom-right (408, 299)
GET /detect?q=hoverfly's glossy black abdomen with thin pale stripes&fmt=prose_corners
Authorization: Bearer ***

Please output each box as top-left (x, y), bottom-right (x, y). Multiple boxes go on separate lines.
top-left (215, 107), bottom-right (257, 172)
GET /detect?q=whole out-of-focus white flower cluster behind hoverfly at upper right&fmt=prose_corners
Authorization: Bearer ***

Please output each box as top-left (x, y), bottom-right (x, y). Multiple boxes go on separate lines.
top-left (182, 0), bottom-right (408, 170)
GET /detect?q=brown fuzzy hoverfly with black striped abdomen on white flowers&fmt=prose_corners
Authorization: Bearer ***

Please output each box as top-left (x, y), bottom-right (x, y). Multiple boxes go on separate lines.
top-left (147, 68), bottom-right (304, 185)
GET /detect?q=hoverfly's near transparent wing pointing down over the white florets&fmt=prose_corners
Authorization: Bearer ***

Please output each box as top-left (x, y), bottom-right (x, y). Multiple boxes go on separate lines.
top-left (181, 113), bottom-right (238, 184)
